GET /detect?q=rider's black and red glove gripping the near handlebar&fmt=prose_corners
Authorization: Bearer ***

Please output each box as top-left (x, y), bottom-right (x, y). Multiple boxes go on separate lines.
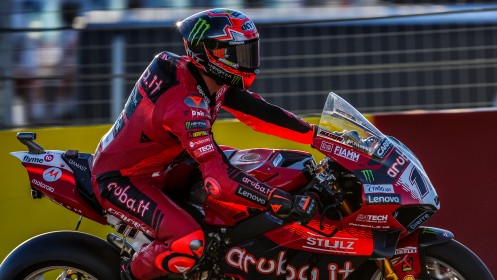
top-left (269, 190), bottom-right (318, 224)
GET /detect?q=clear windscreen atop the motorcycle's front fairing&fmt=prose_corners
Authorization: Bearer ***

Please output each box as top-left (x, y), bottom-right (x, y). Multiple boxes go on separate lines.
top-left (319, 92), bottom-right (385, 155)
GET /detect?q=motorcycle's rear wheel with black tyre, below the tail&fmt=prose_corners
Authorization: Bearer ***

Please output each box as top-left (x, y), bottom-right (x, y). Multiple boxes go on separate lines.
top-left (0, 231), bottom-right (121, 280)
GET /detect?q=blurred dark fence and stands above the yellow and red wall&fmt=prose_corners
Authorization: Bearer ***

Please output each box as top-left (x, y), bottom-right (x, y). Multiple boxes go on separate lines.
top-left (0, 0), bottom-right (497, 128)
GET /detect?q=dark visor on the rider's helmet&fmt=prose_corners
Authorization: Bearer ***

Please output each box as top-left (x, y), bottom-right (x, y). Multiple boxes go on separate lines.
top-left (210, 40), bottom-right (260, 70)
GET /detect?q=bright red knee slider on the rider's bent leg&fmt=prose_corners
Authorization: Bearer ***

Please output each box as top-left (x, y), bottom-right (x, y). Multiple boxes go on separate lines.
top-left (155, 230), bottom-right (205, 273)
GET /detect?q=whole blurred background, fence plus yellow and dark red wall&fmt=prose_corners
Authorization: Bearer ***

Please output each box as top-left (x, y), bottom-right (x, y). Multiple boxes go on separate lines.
top-left (0, 0), bottom-right (497, 275)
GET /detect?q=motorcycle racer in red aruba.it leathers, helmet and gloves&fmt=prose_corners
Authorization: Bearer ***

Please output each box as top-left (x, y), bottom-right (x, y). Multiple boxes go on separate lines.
top-left (93, 9), bottom-right (318, 279)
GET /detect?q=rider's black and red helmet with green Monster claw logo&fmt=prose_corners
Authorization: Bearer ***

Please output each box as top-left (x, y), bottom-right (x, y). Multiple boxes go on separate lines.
top-left (177, 9), bottom-right (259, 89)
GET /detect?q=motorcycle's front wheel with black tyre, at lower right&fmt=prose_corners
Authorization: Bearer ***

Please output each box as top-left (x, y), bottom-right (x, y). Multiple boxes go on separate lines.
top-left (352, 239), bottom-right (495, 280)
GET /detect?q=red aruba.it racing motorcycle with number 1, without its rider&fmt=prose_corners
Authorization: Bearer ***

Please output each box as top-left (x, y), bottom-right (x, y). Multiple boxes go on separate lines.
top-left (0, 93), bottom-right (494, 280)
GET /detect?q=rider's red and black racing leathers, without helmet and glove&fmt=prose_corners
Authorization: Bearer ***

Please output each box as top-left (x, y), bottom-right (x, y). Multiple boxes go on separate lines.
top-left (93, 52), bottom-right (313, 279)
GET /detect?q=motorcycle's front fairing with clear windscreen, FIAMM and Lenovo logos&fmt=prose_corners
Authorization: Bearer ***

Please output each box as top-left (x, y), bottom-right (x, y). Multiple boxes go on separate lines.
top-left (313, 92), bottom-right (439, 209)
